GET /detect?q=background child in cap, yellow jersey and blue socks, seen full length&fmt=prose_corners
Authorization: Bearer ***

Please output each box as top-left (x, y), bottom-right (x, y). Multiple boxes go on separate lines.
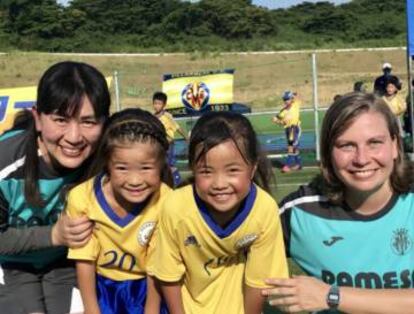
top-left (272, 91), bottom-right (302, 172)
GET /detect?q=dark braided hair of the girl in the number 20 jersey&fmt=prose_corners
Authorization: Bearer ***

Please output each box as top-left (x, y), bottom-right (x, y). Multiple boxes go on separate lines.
top-left (89, 108), bottom-right (172, 186)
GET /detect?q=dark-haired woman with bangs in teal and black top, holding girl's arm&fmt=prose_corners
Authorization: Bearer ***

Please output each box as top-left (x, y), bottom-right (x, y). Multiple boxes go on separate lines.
top-left (0, 62), bottom-right (110, 314)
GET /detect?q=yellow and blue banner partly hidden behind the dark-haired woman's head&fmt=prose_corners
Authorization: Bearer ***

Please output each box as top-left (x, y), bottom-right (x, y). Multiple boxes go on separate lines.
top-left (0, 76), bottom-right (112, 135)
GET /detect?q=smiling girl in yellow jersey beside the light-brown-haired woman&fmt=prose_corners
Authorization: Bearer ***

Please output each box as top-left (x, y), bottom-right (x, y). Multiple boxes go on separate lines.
top-left (149, 111), bottom-right (288, 314)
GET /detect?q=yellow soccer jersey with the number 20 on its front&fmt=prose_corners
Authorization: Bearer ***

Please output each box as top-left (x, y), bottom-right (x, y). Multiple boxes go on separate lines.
top-left (66, 175), bottom-right (171, 281)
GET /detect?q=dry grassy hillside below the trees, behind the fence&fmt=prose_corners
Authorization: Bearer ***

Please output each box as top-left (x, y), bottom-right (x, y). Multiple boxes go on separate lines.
top-left (0, 49), bottom-right (407, 111)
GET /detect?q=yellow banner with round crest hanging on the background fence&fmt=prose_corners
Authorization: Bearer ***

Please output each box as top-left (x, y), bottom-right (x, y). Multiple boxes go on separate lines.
top-left (162, 69), bottom-right (234, 111)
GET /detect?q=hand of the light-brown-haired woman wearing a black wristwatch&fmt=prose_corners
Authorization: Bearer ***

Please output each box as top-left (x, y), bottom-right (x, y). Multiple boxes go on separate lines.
top-left (262, 276), bottom-right (330, 313)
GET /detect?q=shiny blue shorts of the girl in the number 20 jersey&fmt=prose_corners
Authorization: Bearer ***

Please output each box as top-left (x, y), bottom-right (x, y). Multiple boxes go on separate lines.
top-left (96, 274), bottom-right (168, 314)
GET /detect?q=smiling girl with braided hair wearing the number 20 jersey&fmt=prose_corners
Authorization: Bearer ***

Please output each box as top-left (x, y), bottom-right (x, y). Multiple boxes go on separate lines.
top-left (67, 109), bottom-right (172, 314)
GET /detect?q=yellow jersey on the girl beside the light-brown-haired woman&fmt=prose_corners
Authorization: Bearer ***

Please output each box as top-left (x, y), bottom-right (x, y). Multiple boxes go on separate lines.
top-left (148, 185), bottom-right (288, 314)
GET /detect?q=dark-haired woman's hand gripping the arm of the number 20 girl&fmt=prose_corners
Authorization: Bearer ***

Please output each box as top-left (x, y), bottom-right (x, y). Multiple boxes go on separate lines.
top-left (51, 212), bottom-right (94, 248)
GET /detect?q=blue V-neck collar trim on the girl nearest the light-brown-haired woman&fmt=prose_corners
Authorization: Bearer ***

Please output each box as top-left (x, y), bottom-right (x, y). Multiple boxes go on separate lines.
top-left (193, 184), bottom-right (257, 239)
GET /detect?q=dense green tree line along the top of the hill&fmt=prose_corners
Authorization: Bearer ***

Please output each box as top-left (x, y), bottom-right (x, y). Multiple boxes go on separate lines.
top-left (0, 0), bottom-right (406, 52)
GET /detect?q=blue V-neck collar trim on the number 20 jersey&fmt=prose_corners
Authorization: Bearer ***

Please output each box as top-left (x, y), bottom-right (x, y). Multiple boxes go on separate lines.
top-left (93, 173), bottom-right (151, 227)
